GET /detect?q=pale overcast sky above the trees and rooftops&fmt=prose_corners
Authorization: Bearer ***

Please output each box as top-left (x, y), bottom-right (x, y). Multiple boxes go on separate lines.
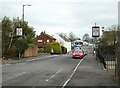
top-left (0, 0), bottom-right (119, 38)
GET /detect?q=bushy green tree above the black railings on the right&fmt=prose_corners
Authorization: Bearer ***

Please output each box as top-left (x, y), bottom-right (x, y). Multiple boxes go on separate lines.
top-left (98, 26), bottom-right (118, 54)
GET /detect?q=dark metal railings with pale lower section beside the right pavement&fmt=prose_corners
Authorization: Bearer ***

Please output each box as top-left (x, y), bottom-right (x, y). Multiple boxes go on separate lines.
top-left (97, 50), bottom-right (115, 70)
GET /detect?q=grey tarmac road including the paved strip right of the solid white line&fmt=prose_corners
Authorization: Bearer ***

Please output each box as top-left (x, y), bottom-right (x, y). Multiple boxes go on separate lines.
top-left (2, 47), bottom-right (116, 88)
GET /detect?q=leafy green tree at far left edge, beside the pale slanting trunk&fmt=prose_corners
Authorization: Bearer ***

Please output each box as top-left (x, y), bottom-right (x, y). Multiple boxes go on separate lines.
top-left (2, 16), bottom-right (13, 56)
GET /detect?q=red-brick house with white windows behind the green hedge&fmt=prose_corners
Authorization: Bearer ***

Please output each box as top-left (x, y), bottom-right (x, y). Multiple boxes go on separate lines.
top-left (34, 33), bottom-right (56, 48)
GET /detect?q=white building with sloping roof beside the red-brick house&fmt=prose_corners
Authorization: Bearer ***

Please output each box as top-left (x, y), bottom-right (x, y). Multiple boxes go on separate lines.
top-left (53, 34), bottom-right (71, 52)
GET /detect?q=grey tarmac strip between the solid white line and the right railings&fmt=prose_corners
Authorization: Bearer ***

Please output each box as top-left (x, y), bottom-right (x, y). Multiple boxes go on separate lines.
top-left (67, 54), bottom-right (118, 88)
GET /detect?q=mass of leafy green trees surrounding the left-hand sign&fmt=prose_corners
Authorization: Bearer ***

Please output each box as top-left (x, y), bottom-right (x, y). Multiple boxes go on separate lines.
top-left (2, 16), bottom-right (35, 57)
